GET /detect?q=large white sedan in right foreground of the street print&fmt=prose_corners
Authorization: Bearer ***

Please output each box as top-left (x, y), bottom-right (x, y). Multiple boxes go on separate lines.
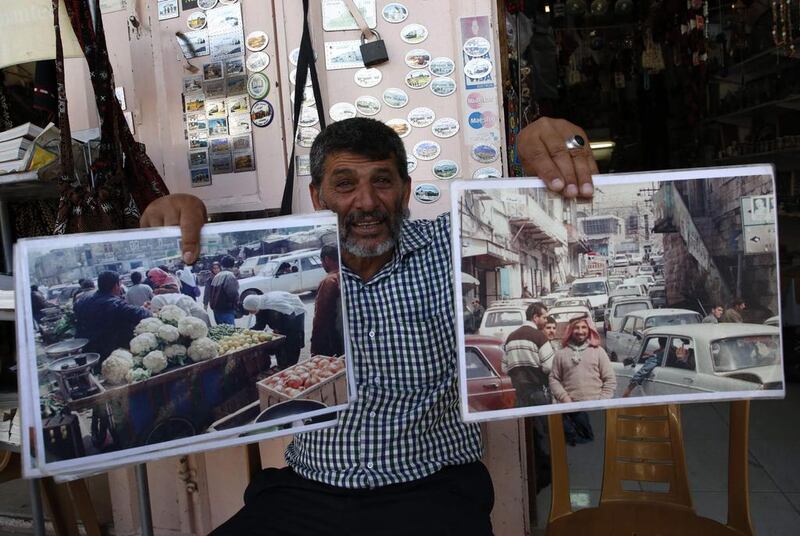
top-left (612, 324), bottom-right (783, 396)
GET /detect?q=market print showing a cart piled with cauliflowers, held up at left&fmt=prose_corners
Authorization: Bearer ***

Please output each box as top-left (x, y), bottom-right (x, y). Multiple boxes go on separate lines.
top-left (17, 214), bottom-right (349, 474)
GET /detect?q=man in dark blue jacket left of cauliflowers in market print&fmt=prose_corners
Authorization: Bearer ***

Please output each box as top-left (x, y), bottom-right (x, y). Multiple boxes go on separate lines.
top-left (75, 272), bottom-right (150, 361)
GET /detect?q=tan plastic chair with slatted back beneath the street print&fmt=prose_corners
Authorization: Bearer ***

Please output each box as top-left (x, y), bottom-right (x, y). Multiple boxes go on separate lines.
top-left (546, 401), bottom-right (754, 536)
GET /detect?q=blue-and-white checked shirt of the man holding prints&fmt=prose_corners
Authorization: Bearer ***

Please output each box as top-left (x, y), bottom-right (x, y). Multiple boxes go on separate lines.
top-left (286, 214), bottom-right (482, 488)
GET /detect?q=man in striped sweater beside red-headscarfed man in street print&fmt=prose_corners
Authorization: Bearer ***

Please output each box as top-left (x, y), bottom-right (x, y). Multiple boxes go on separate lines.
top-left (501, 303), bottom-right (554, 408)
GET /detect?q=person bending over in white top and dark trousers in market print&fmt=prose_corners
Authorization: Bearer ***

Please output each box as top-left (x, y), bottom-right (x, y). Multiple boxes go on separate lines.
top-left (242, 290), bottom-right (306, 369)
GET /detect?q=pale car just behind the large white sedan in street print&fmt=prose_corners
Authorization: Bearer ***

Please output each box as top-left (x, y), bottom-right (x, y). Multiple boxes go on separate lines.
top-left (606, 309), bottom-right (703, 361)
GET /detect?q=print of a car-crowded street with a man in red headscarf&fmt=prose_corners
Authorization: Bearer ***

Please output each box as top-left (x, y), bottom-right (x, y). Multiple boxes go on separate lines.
top-left (452, 166), bottom-right (784, 420)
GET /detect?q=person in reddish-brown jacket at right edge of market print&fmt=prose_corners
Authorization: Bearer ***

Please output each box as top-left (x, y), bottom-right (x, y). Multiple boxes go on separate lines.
top-left (311, 245), bottom-right (344, 356)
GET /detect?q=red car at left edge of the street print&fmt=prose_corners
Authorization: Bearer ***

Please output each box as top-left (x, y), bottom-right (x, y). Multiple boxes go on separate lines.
top-left (464, 335), bottom-right (517, 411)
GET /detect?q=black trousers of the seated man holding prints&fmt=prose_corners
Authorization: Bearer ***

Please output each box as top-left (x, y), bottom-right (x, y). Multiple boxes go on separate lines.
top-left (210, 462), bottom-right (494, 536)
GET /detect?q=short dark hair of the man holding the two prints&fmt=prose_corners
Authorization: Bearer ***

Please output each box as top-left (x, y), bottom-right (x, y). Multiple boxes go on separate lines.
top-left (310, 117), bottom-right (411, 188)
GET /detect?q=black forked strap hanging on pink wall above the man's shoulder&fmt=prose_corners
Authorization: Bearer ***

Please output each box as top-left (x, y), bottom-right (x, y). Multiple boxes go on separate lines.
top-left (280, 0), bottom-right (325, 216)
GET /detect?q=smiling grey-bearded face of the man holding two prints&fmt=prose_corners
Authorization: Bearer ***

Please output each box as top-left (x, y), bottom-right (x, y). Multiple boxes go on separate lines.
top-left (310, 152), bottom-right (411, 257)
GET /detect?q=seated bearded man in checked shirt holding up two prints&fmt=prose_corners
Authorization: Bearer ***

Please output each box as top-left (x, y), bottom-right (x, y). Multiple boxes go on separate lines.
top-left (142, 118), bottom-right (597, 536)
